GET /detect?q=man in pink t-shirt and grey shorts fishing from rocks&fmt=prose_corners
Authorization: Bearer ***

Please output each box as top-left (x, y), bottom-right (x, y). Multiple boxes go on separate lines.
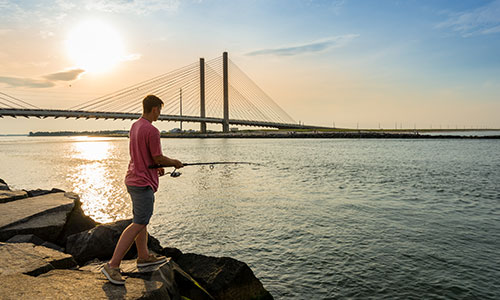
top-left (101, 95), bottom-right (184, 285)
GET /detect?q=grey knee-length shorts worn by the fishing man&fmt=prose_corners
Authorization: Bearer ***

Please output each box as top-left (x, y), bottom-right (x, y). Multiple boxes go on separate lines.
top-left (127, 185), bottom-right (155, 225)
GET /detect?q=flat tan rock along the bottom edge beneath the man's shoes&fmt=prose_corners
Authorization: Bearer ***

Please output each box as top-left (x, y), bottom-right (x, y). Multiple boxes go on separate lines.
top-left (0, 270), bottom-right (172, 299)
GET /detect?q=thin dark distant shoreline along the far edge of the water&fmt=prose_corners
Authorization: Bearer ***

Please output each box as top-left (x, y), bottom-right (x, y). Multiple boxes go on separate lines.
top-left (24, 129), bottom-right (500, 139)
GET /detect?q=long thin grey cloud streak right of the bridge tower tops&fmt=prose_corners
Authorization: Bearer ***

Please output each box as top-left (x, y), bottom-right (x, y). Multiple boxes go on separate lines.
top-left (246, 34), bottom-right (359, 56)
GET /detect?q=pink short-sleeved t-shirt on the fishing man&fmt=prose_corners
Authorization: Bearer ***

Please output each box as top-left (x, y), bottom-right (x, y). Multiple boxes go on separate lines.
top-left (125, 118), bottom-right (162, 192)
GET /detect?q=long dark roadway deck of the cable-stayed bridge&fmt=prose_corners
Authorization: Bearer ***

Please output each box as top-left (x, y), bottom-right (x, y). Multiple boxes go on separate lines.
top-left (0, 108), bottom-right (327, 129)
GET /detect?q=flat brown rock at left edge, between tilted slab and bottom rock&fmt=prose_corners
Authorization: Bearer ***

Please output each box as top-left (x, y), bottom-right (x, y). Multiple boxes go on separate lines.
top-left (0, 242), bottom-right (76, 276)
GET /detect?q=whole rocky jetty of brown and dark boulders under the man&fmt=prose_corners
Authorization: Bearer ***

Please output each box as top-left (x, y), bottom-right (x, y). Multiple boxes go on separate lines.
top-left (0, 179), bottom-right (273, 300)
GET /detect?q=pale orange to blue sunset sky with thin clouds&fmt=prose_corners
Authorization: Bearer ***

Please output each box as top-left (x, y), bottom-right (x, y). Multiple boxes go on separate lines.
top-left (0, 0), bottom-right (500, 134)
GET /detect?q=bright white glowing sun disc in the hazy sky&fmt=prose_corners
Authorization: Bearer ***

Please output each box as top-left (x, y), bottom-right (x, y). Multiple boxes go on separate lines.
top-left (66, 20), bottom-right (125, 73)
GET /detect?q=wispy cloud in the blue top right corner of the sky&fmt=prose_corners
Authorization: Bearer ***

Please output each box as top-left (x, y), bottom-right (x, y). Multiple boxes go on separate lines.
top-left (437, 0), bottom-right (500, 37)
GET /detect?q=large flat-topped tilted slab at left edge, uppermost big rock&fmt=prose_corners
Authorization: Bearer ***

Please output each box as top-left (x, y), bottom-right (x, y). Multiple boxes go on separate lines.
top-left (0, 193), bottom-right (77, 242)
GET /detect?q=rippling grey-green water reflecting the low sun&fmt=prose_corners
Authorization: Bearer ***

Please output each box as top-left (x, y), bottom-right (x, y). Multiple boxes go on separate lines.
top-left (0, 137), bottom-right (500, 299)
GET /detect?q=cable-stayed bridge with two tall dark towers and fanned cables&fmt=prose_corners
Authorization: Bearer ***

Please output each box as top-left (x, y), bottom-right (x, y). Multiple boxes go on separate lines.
top-left (0, 52), bottom-right (321, 132)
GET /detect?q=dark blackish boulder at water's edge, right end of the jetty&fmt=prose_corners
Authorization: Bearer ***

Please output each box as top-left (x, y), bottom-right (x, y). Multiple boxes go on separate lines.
top-left (176, 253), bottom-right (273, 300)
